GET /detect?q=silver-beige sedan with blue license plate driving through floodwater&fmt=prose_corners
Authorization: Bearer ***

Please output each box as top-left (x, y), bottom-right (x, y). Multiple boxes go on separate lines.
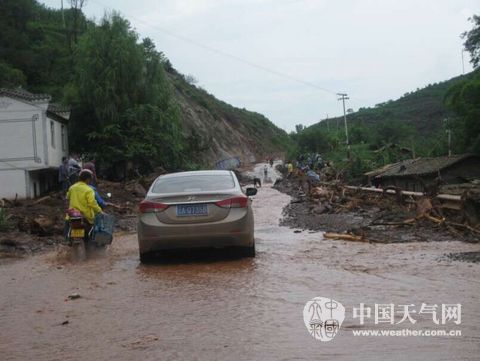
top-left (138, 170), bottom-right (257, 262)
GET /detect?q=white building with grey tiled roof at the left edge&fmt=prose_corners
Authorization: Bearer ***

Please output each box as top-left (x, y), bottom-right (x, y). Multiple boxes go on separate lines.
top-left (0, 89), bottom-right (70, 199)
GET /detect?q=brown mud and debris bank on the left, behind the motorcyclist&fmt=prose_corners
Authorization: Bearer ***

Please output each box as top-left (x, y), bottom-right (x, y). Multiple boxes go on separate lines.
top-left (0, 168), bottom-right (165, 257)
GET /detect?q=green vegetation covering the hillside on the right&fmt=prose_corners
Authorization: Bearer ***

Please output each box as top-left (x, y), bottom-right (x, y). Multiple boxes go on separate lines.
top-left (290, 16), bottom-right (480, 179)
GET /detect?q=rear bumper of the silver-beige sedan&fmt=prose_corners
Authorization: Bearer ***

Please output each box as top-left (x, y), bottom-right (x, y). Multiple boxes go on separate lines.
top-left (138, 209), bottom-right (253, 253)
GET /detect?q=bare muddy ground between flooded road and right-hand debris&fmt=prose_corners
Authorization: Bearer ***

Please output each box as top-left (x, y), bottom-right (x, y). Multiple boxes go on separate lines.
top-left (275, 174), bottom-right (480, 243)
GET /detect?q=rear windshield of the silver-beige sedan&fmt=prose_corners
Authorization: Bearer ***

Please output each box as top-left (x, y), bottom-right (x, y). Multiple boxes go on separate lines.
top-left (152, 174), bottom-right (235, 193)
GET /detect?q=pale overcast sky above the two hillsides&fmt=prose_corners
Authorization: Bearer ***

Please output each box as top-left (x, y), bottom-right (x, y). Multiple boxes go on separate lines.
top-left (40, 0), bottom-right (480, 131)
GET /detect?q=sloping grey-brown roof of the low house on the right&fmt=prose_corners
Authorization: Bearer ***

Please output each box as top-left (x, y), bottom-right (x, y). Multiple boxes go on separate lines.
top-left (365, 154), bottom-right (477, 178)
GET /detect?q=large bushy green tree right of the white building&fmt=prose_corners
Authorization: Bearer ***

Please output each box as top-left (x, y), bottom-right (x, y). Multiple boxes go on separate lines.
top-left (69, 13), bottom-right (183, 178)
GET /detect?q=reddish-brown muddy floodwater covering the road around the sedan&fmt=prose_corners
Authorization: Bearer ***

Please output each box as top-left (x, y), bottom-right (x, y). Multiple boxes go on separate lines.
top-left (0, 165), bottom-right (480, 360)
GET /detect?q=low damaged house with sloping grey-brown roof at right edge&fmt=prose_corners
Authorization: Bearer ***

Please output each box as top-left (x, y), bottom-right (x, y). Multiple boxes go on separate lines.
top-left (365, 154), bottom-right (480, 192)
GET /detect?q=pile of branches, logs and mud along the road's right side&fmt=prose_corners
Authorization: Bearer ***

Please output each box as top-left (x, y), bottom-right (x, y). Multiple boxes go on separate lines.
top-left (275, 171), bottom-right (480, 243)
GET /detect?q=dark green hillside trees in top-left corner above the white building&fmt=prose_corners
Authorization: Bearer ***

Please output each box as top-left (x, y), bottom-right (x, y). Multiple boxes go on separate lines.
top-left (0, 0), bottom-right (89, 99)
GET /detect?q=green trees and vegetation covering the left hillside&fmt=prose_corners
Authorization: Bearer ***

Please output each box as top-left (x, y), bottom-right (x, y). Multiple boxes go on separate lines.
top-left (0, 0), bottom-right (289, 178)
